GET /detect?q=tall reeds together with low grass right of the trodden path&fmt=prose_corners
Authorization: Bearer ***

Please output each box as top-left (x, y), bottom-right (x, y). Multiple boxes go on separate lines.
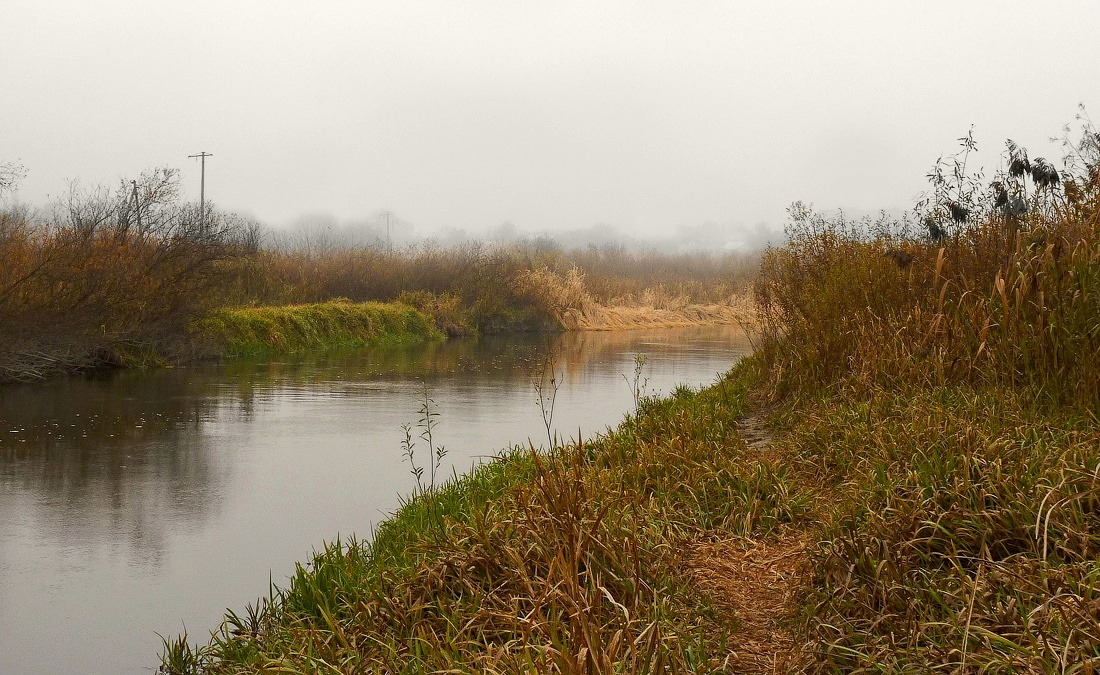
top-left (757, 117), bottom-right (1100, 673)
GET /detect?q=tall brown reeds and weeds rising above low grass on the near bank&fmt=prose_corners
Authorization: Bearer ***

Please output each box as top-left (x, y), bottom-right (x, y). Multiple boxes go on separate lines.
top-left (756, 131), bottom-right (1100, 410)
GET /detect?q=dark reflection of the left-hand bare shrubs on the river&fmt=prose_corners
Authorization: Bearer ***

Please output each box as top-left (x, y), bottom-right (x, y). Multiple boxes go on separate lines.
top-left (0, 374), bottom-right (226, 564)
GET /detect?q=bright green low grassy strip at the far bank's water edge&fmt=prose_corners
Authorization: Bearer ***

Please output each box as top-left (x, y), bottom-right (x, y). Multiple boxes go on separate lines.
top-left (191, 301), bottom-right (443, 356)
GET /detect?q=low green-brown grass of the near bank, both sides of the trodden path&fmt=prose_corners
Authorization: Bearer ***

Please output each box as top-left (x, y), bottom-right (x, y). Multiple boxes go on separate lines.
top-left (166, 241), bottom-right (1100, 673)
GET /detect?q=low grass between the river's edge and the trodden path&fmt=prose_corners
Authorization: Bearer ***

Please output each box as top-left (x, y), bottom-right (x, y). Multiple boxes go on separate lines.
top-left (162, 356), bottom-right (827, 673)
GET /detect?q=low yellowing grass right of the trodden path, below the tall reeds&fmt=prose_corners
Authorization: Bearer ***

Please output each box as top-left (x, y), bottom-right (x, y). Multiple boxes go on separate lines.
top-left (777, 385), bottom-right (1100, 672)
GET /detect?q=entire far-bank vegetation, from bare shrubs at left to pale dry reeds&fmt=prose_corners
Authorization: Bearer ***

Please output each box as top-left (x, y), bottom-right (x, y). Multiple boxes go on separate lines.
top-left (0, 169), bottom-right (758, 383)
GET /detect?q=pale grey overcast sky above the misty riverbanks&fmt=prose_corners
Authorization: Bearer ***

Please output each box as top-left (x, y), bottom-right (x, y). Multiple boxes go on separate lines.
top-left (0, 0), bottom-right (1100, 240)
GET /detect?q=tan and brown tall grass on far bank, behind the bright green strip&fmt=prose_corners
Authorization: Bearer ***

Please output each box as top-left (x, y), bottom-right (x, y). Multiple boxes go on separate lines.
top-left (216, 242), bottom-right (756, 334)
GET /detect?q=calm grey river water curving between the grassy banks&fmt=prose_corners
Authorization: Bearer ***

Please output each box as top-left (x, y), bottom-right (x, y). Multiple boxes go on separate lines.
top-left (0, 328), bottom-right (749, 673)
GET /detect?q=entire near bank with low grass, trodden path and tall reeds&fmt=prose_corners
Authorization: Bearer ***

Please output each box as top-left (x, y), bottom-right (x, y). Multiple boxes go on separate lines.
top-left (162, 119), bottom-right (1100, 673)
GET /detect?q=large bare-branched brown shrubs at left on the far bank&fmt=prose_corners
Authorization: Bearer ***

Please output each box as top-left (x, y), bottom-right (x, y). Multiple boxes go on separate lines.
top-left (0, 170), bottom-right (252, 381)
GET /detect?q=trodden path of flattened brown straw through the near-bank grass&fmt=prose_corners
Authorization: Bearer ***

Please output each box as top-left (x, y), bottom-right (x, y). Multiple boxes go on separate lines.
top-left (689, 414), bottom-right (809, 673)
